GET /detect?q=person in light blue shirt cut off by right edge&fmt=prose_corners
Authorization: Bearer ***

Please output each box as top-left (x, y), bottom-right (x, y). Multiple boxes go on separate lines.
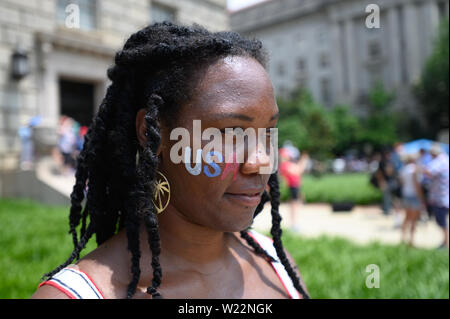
top-left (423, 144), bottom-right (449, 248)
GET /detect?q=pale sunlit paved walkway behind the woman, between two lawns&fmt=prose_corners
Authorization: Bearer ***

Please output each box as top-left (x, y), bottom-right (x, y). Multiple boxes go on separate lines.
top-left (254, 204), bottom-right (443, 248)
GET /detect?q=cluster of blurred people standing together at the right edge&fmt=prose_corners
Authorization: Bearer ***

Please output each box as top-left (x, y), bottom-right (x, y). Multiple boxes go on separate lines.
top-left (372, 143), bottom-right (449, 248)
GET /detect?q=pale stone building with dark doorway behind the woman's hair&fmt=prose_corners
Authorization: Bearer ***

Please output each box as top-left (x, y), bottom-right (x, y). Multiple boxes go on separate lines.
top-left (0, 0), bottom-right (229, 169)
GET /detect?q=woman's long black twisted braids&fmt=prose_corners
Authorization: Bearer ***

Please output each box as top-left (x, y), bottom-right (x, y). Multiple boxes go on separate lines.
top-left (43, 22), bottom-right (309, 298)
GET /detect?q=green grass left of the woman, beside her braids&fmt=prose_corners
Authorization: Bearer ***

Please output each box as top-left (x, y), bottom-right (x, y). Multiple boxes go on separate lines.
top-left (0, 199), bottom-right (96, 298)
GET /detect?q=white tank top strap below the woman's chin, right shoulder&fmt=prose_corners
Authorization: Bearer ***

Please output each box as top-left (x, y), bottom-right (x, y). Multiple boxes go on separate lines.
top-left (248, 230), bottom-right (301, 299)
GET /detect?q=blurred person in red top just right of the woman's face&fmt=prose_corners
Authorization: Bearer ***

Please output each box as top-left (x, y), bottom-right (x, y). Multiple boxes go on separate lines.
top-left (280, 149), bottom-right (309, 232)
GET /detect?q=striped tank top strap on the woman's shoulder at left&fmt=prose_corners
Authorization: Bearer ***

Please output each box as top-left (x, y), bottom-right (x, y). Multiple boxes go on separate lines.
top-left (39, 267), bottom-right (105, 299)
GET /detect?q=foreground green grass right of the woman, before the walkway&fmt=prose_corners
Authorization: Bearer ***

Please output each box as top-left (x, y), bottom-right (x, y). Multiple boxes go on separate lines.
top-left (283, 231), bottom-right (449, 299)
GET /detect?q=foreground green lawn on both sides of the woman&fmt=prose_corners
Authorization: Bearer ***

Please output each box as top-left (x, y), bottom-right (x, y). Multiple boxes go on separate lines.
top-left (0, 199), bottom-right (449, 298)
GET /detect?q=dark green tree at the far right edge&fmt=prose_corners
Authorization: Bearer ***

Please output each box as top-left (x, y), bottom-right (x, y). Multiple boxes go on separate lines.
top-left (415, 19), bottom-right (449, 139)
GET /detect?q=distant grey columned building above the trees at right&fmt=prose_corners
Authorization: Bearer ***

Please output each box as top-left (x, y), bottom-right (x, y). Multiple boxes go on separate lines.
top-left (230, 0), bottom-right (449, 119)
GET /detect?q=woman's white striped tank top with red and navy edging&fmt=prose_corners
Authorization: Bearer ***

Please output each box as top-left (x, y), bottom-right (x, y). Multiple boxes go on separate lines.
top-left (39, 230), bottom-right (301, 299)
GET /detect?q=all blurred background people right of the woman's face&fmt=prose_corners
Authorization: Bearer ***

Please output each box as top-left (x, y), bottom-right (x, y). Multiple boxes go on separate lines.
top-left (279, 142), bottom-right (449, 248)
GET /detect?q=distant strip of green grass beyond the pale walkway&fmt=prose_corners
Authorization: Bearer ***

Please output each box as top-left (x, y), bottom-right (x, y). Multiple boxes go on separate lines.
top-left (280, 173), bottom-right (382, 205)
